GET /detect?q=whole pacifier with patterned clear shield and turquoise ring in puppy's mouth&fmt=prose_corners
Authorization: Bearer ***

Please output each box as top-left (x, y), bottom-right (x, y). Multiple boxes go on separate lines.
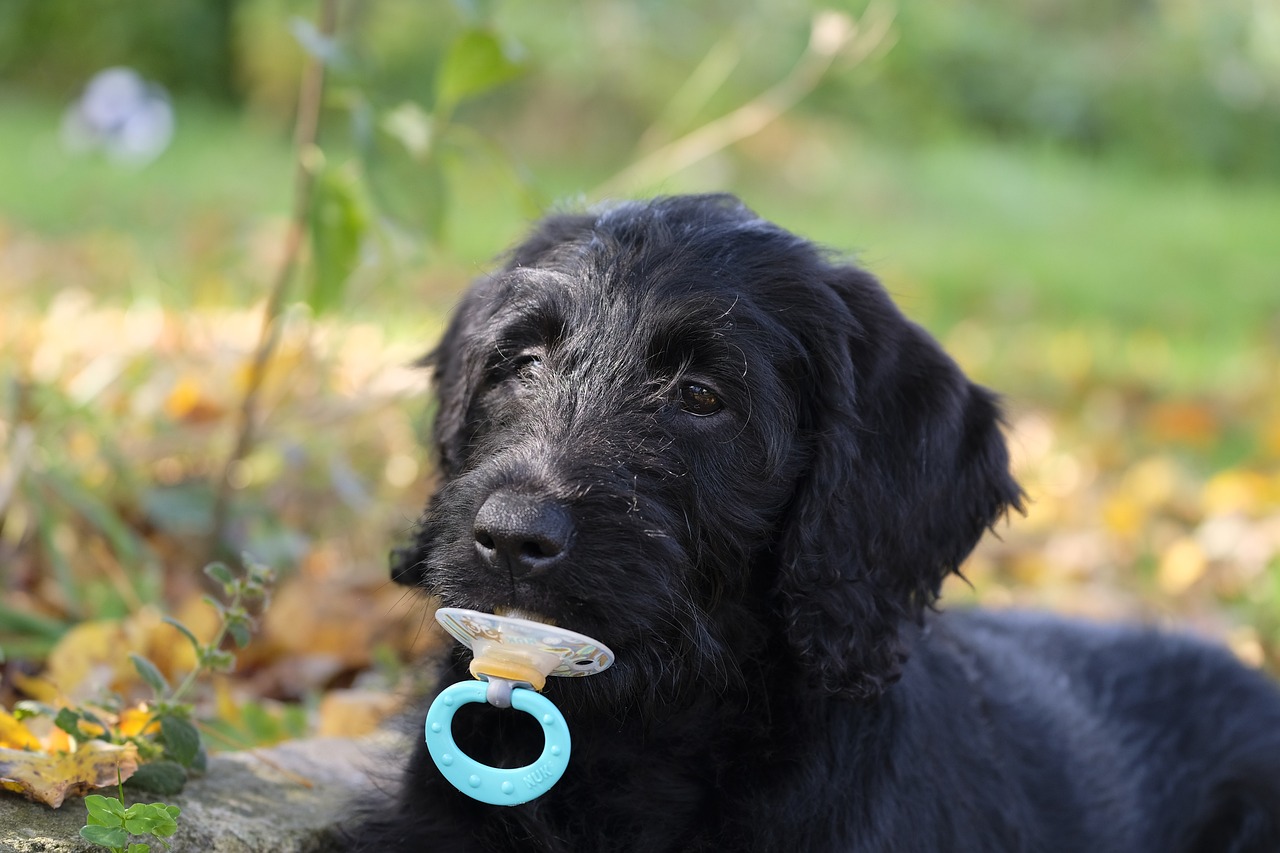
top-left (426, 607), bottom-right (613, 806)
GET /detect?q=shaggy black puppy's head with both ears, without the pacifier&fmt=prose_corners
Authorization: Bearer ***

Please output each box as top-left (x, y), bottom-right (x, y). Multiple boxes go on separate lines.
top-left (394, 196), bottom-right (1020, 698)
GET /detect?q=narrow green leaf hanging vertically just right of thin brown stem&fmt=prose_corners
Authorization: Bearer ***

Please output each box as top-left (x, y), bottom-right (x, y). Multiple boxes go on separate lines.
top-left (307, 168), bottom-right (369, 315)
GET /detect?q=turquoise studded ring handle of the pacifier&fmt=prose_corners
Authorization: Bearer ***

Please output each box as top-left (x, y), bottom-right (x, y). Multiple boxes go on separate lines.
top-left (426, 681), bottom-right (570, 806)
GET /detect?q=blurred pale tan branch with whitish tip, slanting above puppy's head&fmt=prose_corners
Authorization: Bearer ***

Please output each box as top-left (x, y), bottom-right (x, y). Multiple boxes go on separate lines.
top-left (591, 3), bottom-right (893, 197)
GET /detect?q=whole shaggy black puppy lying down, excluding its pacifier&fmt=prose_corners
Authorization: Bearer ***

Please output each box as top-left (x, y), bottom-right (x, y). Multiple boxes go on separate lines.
top-left (358, 196), bottom-right (1280, 853)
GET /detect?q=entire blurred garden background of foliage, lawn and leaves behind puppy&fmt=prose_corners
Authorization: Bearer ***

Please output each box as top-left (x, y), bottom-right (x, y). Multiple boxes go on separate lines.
top-left (0, 0), bottom-right (1280, 742)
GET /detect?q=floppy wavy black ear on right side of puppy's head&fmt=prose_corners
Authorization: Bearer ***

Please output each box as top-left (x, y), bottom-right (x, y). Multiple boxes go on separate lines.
top-left (776, 268), bottom-right (1021, 699)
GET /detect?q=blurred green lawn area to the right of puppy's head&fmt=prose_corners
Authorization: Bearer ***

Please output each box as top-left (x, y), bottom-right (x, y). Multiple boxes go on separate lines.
top-left (742, 129), bottom-right (1280, 348)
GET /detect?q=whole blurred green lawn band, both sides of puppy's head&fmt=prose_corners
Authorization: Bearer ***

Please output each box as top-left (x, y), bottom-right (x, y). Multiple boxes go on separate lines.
top-left (0, 96), bottom-right (1280, 391)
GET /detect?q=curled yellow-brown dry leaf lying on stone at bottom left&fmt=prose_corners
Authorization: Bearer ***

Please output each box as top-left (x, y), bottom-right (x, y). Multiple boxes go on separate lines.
top-left (0, 740), bottom-right (138, 808)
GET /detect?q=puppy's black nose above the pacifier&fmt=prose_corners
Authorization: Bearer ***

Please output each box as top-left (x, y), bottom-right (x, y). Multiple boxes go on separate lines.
top-left (474, 489), bottom-right (573, 578)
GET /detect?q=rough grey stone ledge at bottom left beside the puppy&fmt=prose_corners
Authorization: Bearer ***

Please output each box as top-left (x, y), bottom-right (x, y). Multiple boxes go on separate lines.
top-left (0, 735), bottom-right (403, 853)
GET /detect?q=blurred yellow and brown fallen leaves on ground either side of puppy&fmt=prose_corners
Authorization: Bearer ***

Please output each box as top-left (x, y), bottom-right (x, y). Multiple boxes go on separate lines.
top-left (0, 222), bottom-right (1280, 800)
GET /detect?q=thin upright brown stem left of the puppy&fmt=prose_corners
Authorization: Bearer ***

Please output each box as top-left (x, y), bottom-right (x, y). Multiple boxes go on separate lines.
top-left (209, 0), bottom-right (339, 558)
